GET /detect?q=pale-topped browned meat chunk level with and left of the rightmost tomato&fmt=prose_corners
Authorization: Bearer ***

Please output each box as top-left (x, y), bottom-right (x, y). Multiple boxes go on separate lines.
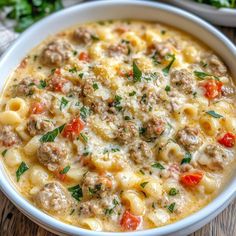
top-left (176, 127), bottom-right (202, 151)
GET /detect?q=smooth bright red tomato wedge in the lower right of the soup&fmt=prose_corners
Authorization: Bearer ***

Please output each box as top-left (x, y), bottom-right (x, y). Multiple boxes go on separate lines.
top-left (180, 171), bottom-right (203, 187)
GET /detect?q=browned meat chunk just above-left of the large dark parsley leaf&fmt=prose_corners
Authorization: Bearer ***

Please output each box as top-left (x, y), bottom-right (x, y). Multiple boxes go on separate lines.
top-left (27, 115), bottom-right (54, 136)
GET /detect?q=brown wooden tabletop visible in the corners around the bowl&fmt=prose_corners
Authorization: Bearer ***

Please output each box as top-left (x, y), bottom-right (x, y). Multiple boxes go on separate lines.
top-left (0, 27), bottom-right (236, 236)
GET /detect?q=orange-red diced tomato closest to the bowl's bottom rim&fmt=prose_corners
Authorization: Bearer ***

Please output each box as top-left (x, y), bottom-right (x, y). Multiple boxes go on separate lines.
top-left (120, 210), bottom-right (141, 231)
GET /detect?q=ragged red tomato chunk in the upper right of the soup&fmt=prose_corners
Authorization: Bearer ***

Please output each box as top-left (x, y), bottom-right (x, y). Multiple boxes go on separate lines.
top-left (203, 80), bottom-right (223, 99)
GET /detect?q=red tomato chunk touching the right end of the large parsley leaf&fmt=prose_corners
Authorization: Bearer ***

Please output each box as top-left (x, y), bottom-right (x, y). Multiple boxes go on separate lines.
top-left (62, 118), bottom-right (85, 140)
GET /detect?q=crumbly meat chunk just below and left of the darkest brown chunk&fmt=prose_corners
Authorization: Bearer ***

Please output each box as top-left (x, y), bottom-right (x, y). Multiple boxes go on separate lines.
top-left (129, 141), bottom-right (153, 164)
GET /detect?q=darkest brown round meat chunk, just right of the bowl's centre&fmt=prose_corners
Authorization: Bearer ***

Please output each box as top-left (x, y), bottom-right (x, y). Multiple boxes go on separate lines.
top-left (143, 117), bottom-right (165, 140)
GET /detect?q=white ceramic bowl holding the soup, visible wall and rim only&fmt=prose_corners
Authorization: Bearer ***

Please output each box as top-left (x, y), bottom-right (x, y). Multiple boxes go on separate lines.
top-left (0, 0), bottom-right (236, 236)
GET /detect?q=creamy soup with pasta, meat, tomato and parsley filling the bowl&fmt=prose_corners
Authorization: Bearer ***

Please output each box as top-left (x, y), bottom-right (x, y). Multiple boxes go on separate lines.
top-left (0, 21), bottom-right (236, 232)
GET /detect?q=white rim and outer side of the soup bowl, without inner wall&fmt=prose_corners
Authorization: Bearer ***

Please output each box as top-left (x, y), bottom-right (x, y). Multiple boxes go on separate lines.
top-left (0, 0), bottom-right (236, 236)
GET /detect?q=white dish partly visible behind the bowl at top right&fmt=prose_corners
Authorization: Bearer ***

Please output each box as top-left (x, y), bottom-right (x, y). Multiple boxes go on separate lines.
top-left (162, 0), bottom-right (236, 27)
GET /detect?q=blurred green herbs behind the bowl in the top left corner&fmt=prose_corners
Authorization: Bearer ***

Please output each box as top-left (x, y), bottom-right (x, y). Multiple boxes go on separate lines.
top-left (0, 0), bottom-right (63, 32)
